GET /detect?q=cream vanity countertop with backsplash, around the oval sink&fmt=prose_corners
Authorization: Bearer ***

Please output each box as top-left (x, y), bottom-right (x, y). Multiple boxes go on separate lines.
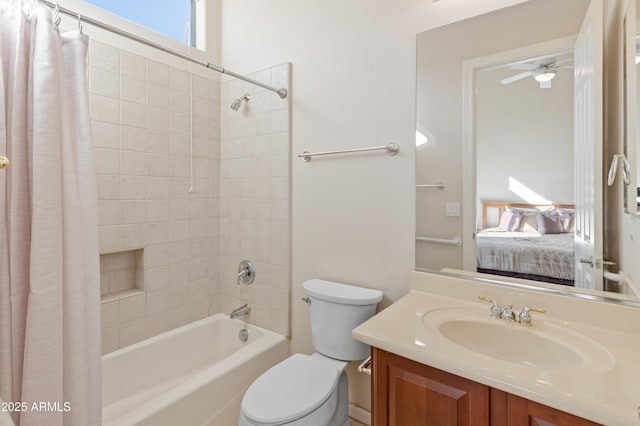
top-left (353, 272), bottom-right (640, 425)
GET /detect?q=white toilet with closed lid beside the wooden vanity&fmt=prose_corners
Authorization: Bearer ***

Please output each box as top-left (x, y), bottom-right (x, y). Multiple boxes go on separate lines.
top-left (238, 279), bottom-right (382, 426)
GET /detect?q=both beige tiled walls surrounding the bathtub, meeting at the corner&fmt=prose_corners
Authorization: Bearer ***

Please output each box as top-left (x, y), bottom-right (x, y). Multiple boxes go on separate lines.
top-left (88, 41), bottom-right (291, 353)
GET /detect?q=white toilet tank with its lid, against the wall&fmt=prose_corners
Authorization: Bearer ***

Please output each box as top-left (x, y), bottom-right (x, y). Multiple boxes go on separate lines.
top-left (302, 279), bottom-right (382, 361)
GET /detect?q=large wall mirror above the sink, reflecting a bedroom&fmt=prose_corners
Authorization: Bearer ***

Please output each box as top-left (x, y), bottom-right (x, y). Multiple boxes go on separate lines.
top-left (416, 0), bottom-right (640, 300)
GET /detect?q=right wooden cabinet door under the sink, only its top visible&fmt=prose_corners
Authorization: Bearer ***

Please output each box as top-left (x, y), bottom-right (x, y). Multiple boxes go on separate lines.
top-left (507, 394), bottom-right (598, 426)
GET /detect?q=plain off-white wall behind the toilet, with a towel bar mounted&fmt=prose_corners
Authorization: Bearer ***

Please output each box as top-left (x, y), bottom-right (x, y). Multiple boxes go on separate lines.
top-left (222, 0), bottom-right (518, 412)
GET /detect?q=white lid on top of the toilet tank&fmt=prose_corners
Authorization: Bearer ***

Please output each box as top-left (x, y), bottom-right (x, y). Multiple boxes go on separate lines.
top-left (302, 279), bottom-right (382, 305)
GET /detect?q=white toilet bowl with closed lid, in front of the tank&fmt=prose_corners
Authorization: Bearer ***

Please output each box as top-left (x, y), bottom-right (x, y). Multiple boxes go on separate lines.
top-left (241, 354), bottom-right (341, 426)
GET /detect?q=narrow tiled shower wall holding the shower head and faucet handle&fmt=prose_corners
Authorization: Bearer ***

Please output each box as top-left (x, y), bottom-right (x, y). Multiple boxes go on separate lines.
top-left (220, 63), bottom-right (291, 336)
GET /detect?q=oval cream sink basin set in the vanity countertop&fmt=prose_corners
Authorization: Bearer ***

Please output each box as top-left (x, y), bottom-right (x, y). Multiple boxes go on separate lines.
top-left (423, 308), bottom-right (614, 372)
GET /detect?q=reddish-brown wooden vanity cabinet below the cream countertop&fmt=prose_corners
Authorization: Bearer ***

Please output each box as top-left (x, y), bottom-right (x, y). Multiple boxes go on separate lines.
top-left (371, 348), bottom-right (597, 426)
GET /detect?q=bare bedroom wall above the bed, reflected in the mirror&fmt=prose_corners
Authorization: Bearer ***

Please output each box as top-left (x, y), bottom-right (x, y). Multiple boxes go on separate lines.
top-left (476, 65), bottom-right (573, 211)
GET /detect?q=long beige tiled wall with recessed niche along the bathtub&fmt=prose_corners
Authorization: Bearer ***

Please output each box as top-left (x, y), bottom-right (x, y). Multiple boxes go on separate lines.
top-left (88, 41), bottom-right (220, 353)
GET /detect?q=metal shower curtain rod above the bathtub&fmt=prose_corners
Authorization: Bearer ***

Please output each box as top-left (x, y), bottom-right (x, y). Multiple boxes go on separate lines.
top-left (39, 0), bottom-right (287, 99)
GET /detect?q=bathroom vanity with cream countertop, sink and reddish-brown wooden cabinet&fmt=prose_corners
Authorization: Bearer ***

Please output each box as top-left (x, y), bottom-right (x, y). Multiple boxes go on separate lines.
top-left (353, 272), bottom-right (640, 426)
